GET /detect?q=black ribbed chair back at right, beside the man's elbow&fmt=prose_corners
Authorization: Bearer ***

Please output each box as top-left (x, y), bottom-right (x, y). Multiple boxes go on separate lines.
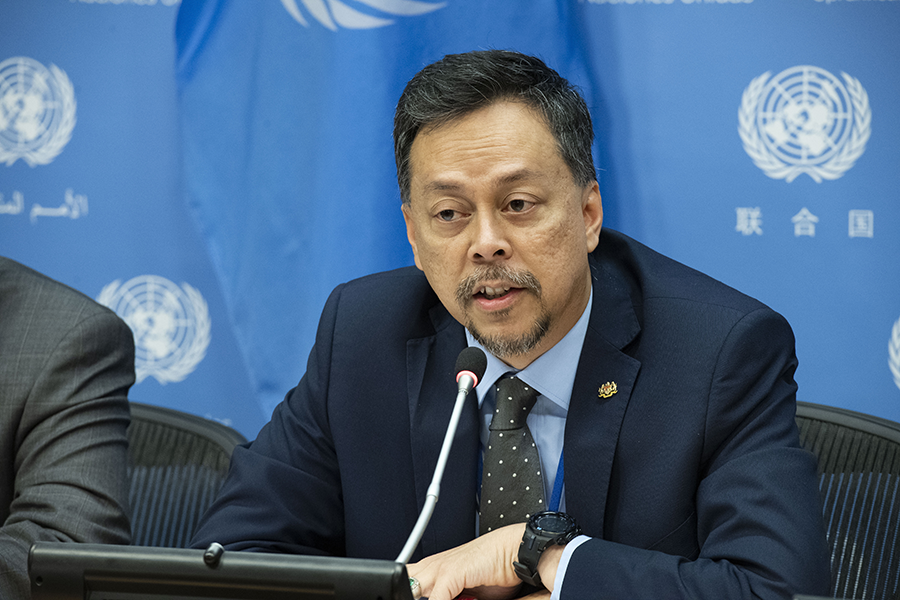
top-left (797, 402), bottom-right (900, 600)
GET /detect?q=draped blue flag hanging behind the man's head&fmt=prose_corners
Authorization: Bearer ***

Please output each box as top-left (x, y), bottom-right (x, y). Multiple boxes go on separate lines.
top-left (176, 0), bottom-right (590, 413)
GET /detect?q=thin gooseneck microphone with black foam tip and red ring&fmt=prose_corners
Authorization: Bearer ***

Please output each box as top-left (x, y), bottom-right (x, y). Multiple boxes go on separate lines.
top-left (395, 347), bottom-right (487, 564)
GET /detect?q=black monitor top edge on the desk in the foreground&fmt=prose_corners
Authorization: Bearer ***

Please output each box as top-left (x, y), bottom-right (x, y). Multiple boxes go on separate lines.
top-left (28, 542), bottom-right (412, 600)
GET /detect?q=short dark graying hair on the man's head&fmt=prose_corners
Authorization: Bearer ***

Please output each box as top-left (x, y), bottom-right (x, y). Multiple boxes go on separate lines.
top-left (394, 50), bottom-right (597, 202)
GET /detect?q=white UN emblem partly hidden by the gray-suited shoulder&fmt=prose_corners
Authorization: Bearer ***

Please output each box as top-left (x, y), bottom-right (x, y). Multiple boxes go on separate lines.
top-left (97, 275), bottom-right (210, 384)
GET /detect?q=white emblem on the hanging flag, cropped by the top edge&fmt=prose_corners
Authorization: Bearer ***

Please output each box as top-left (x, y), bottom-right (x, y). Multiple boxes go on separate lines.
top-left (281, 0), bottom-right (447, 31)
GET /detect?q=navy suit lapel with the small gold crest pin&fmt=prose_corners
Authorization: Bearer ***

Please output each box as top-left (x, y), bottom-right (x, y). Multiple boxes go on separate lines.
top-left (563, 255), bottom-right (640, 537)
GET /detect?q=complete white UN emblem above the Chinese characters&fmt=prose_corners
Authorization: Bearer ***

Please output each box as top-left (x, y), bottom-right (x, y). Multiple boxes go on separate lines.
top-left (738, 66), bottom-right (872, 183)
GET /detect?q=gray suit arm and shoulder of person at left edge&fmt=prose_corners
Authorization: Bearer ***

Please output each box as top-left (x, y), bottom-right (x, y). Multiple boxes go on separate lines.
top-left (0, 257), bottom-right (134, 599)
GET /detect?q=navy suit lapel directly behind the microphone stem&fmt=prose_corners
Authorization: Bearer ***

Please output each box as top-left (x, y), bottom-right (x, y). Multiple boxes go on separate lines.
top-left (406, 305), bottom-right (479, 560)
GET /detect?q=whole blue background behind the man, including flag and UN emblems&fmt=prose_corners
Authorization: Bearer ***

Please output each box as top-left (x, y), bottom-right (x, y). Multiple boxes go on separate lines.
top-left (0, 0), bottom-right (900, 438)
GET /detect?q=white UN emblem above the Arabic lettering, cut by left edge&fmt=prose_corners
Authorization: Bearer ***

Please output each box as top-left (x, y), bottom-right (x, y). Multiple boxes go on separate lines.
top-left (0, 56), bottom-right (75, 167)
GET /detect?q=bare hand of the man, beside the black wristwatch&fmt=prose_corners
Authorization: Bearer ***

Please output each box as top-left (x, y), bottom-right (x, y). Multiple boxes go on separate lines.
top-left (406, 523), bottom-right (528, 600)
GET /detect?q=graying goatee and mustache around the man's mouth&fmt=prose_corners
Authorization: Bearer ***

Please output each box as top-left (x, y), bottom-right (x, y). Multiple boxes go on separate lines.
top-left (456, 265), bottom-right (552, 359)
